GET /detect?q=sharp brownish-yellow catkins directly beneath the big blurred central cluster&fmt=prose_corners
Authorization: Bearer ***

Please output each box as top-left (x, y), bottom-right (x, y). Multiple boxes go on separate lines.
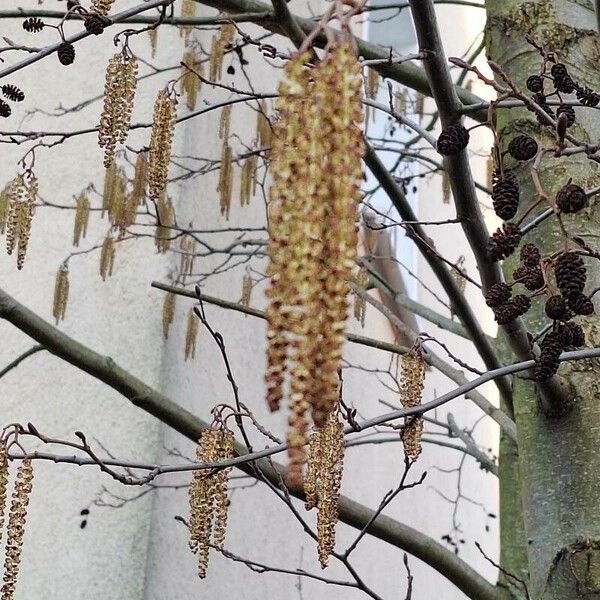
top-left (304, 412), bottom-right (344, 568)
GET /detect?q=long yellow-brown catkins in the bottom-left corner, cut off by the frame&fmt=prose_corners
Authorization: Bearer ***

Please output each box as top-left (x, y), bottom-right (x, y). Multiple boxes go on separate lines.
top-left (0, 441), bottom-right (33, 600)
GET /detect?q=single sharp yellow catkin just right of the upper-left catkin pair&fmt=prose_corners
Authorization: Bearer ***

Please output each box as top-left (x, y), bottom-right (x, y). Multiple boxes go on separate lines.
top-left (148, 89), bottom-right (177, 202)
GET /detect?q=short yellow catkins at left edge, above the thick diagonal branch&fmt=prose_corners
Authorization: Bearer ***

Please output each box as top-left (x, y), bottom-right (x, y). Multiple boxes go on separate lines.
top-left (6, 172), bottom-right (38, 270)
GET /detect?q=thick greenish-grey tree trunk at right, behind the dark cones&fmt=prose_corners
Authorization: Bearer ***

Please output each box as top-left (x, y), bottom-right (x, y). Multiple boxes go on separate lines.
top-left (486, 0), bottom-right (600, 600)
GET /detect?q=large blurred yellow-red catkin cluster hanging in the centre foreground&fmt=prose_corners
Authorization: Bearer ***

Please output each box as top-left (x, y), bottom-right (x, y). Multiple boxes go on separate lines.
top-left (266, 42), bottom-right (363, 487)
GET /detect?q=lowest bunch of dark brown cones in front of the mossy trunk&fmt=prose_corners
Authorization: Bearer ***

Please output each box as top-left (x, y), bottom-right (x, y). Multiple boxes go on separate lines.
top-left (485, 244), bottom-right (594, 381)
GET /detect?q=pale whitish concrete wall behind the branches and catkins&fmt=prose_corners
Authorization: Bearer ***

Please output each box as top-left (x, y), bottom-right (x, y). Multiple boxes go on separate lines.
top-left (0, 0), bottom-right (497, 600)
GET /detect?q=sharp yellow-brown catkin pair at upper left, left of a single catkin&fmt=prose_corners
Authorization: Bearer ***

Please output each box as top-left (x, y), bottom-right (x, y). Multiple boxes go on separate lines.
top-left (98, 52), bottom-right (138, 168)
